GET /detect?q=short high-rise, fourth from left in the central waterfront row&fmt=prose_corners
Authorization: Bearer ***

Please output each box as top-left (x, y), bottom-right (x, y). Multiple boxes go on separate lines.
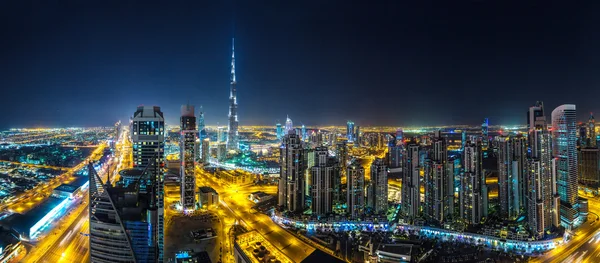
top-left (368, 158), bottom-right (388, 215)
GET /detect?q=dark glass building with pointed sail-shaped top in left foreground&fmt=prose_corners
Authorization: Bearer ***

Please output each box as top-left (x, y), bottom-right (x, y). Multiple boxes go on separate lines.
top-left (88, 163), bottom-right (162, 263)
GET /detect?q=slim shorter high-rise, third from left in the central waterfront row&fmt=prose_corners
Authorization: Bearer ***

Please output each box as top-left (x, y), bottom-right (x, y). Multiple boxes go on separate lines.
top-left (346, 160), bottom-right (365, 218)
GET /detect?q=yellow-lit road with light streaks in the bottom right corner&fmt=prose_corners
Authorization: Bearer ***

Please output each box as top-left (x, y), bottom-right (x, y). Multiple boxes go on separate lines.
top-left (531, 194), bottom-right (600, 263)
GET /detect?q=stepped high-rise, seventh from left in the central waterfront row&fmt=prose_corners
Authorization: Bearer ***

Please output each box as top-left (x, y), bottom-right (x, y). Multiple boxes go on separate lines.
top-left (459, 143), bottom-right (488, 224)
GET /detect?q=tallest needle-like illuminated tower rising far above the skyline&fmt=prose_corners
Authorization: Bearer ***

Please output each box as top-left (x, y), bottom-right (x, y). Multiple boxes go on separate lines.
top-left (227, 38), bottom-right (240, 151)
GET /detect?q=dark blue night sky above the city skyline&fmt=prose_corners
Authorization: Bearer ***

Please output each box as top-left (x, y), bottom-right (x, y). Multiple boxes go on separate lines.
top-left (0, 0), bottom-right (600, 128)
